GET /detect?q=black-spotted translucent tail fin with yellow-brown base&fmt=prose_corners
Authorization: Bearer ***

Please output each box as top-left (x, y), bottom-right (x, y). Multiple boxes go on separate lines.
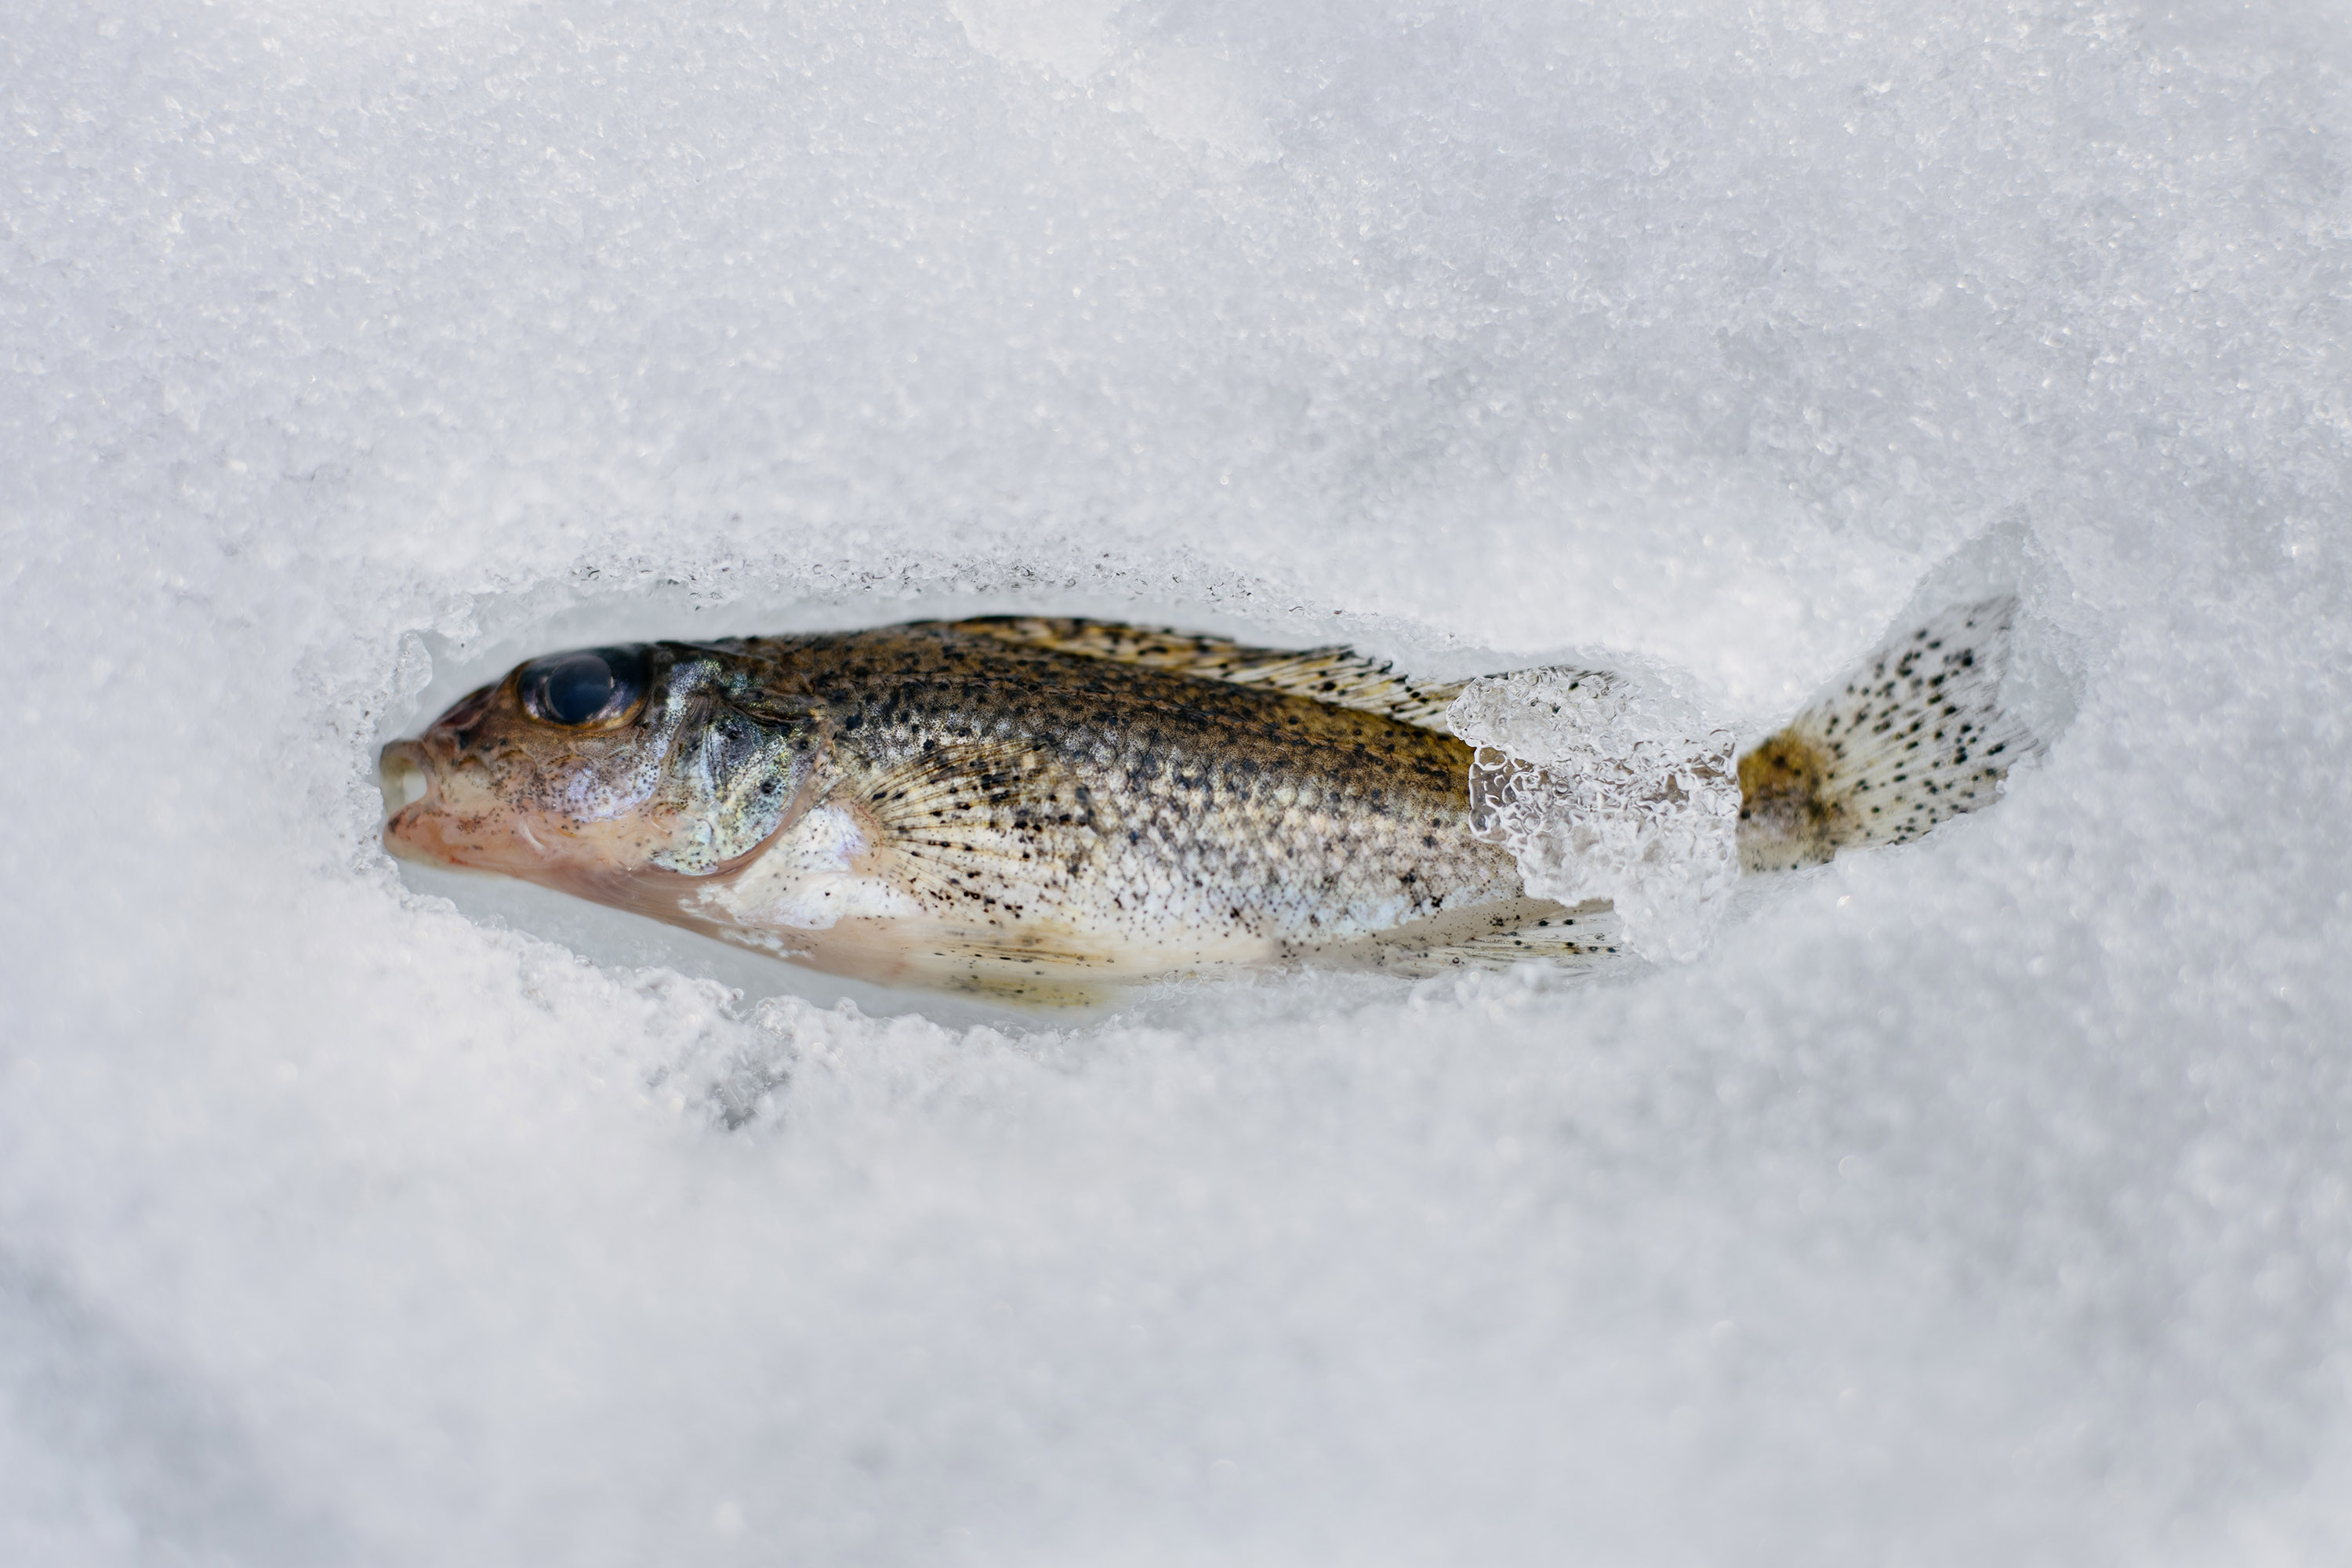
top-left (1738, 600), bottom-right (2034, 872)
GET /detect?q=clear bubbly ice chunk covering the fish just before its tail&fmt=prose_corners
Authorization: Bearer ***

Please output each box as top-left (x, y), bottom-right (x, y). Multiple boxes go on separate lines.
top-left (1446, 670), bottom-right (1740, 959)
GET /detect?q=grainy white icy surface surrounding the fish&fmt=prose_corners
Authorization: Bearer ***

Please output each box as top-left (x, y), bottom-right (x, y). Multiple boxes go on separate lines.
top-left (0, 0), bottom-right (2352, 1563)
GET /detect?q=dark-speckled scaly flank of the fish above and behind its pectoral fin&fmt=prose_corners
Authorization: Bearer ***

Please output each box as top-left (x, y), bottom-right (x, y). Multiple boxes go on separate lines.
top-left (717, 626), bottom-right (1517, 947)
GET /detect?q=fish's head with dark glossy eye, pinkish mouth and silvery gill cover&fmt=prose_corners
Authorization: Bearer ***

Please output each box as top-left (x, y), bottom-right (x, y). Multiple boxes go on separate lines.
top-left (381, 642), bottom-right (821, 912)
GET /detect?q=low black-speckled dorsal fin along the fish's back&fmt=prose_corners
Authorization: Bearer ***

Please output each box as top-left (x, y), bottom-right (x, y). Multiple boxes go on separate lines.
top-left (950, 616), bottom-right (1470, 734)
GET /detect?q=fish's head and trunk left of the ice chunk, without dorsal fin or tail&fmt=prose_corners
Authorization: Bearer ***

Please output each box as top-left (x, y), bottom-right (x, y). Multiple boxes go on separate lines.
top-left (386, 623), bottom-right (1557, 996)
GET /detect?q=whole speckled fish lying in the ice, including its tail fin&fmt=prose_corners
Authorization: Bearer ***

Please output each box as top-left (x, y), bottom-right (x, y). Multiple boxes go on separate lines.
top-left (383, 600), bottom-right (2030, 1001)
